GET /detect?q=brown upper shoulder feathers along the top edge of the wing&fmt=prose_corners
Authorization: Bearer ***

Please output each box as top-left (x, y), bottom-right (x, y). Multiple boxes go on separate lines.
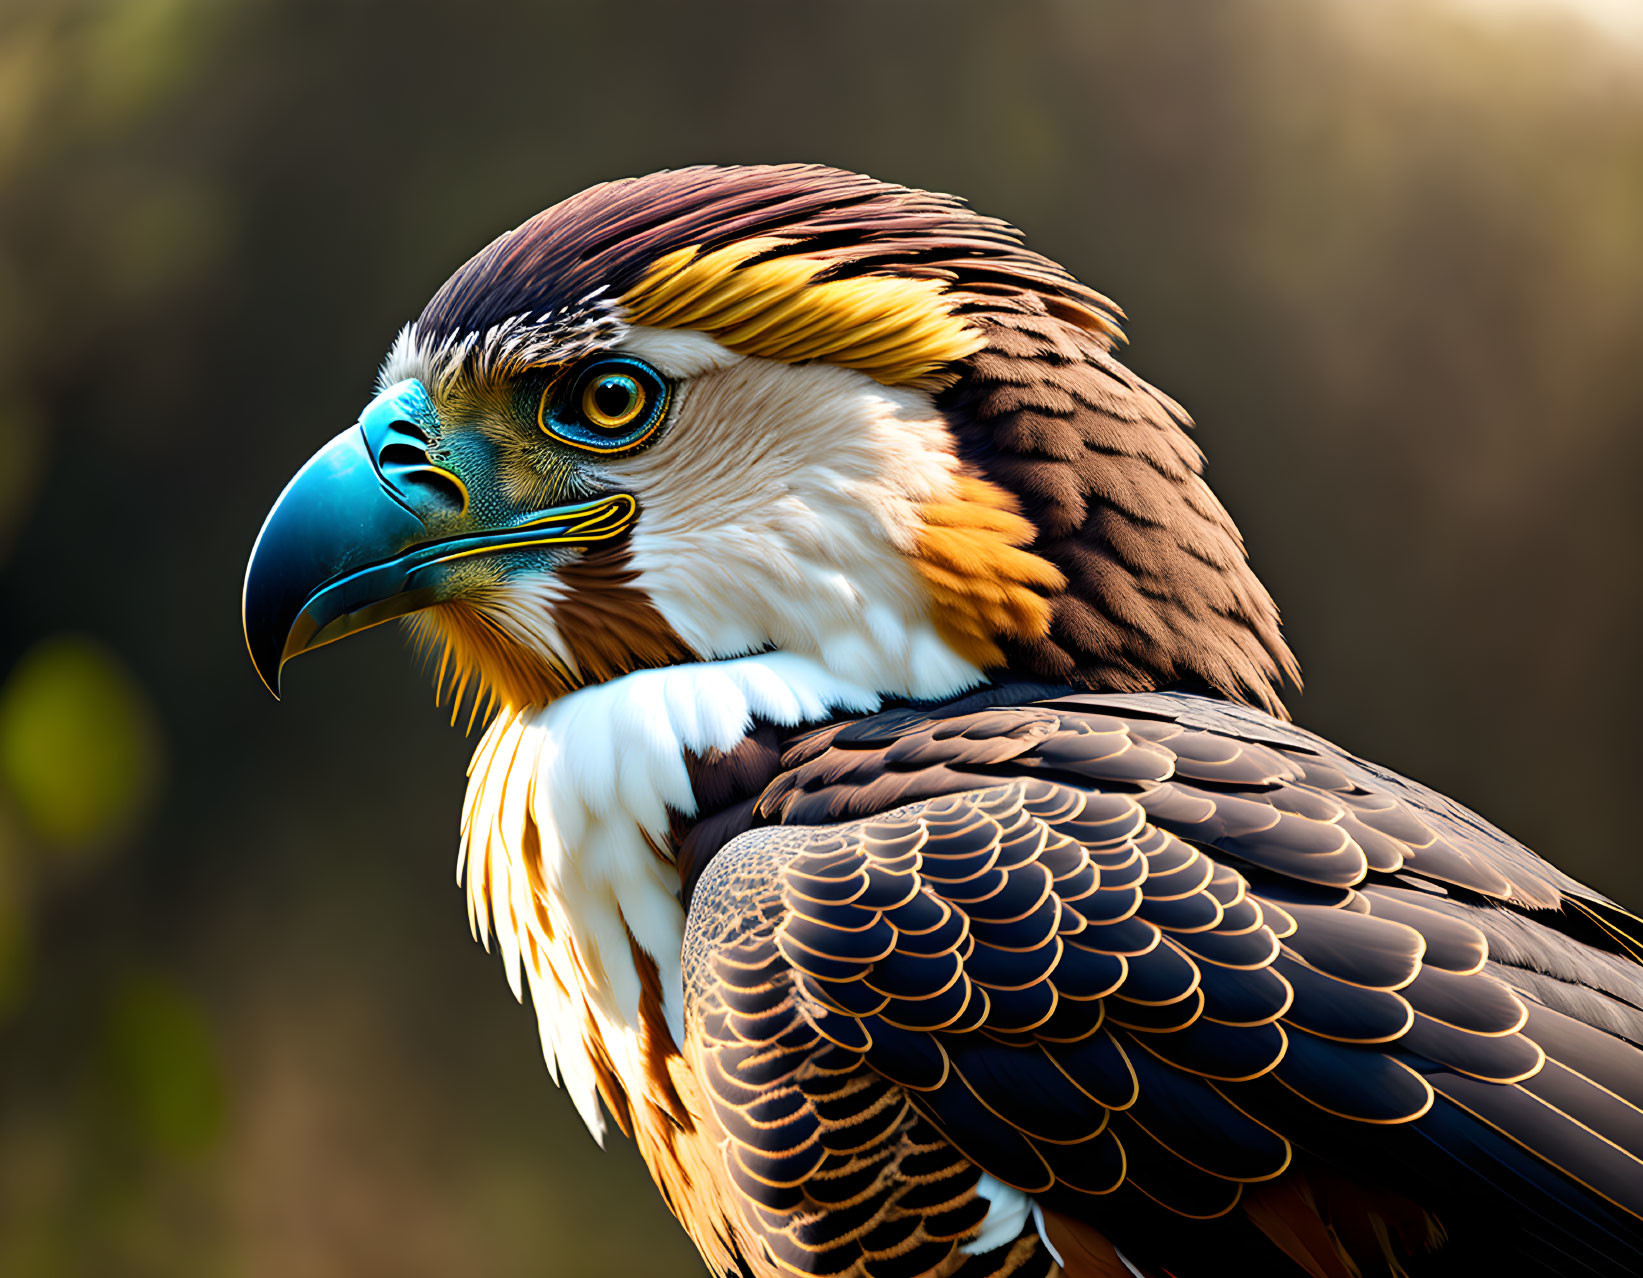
top-left (685, 685), bottom-right (1604, 912)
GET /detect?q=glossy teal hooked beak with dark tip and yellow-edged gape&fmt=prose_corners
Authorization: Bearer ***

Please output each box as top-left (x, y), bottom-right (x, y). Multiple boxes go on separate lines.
top-left (242, 379), bottom-right (637, 696)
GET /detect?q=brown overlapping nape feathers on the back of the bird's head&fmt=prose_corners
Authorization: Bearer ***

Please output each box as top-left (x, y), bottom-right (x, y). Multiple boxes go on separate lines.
top-left (938, 296), bottom-right (1300, 715)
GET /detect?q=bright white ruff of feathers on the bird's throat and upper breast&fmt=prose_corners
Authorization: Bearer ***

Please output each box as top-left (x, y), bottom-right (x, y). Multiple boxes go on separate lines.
top-left (457, 652), bottom-right (926, 1143)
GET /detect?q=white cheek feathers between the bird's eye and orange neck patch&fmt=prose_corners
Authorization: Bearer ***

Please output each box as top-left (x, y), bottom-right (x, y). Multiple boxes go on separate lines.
top-left (603, 329), bottom-right (981, 696)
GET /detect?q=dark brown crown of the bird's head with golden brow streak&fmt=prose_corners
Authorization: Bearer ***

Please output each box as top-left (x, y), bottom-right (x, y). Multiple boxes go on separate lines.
top-left (416, 164), bottom-right (1119, 386)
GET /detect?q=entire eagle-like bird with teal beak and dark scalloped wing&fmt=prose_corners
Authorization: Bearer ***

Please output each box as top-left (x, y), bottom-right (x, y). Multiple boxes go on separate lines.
top-left (243, 164), bottom-right (1643, 1278)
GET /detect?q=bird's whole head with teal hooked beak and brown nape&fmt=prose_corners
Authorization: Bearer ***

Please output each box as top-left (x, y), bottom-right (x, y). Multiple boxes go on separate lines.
top-left (245, 166), bottom-right (1293, 710)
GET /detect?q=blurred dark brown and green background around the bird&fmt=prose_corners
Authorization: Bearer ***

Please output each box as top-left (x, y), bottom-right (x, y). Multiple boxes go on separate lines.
top-left (0, 0), bottom-right (1643, 1278)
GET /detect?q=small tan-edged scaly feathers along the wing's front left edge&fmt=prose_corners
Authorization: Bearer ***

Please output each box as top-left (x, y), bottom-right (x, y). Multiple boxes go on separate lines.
top-left (685, 830), bottom-right (1050, 1278)
